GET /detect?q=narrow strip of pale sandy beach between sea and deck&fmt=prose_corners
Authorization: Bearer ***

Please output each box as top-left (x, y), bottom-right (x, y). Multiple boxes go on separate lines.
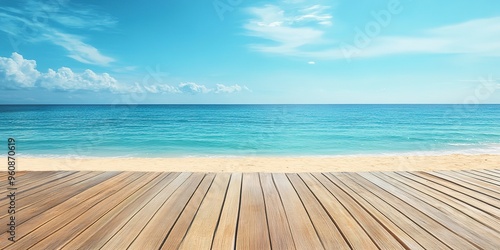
top-left (18, 154), bottom-right (500, 173)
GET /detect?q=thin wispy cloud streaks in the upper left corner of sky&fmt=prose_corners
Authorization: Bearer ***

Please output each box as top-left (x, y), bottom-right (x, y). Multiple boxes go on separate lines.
top-left (0, 1), bottom-right (117, 66)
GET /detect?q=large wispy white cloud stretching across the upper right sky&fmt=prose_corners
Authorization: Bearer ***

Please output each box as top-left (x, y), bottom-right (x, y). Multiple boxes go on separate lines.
top-left (243, 1), bottom-right (500, 60)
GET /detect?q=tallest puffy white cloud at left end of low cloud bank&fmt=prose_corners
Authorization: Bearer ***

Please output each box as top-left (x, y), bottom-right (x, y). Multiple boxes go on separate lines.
top-left (0, 52), bottom-right (40, 88)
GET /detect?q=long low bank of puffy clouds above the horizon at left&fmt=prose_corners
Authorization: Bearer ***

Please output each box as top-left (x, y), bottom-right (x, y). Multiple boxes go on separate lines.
top-left (0, 52), bottom-right (250, 94)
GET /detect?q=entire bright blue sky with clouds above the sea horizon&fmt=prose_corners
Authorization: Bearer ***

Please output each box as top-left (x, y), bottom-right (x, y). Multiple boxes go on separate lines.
top-left (0, 0), bottom-right (500, 104)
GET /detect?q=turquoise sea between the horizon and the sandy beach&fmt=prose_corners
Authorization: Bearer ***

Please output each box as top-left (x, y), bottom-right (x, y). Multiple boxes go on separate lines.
top-left (0, 105), bottom-right (500, 157)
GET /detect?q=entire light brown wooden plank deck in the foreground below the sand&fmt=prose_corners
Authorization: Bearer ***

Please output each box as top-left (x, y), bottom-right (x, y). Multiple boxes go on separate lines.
top-left (0, 170), bottom-right (500, 250)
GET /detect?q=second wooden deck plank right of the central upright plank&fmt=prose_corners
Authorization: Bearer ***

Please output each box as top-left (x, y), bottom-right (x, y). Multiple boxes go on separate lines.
top-left (273, 174), bottom-right (323, 249)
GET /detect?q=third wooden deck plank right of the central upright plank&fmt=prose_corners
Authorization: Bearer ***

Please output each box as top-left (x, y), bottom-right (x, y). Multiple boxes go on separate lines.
top-left (287, 174), bottom-right (349, 249)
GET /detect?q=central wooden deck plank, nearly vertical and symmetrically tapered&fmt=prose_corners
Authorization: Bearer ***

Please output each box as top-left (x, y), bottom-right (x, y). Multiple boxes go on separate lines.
top-left (236, 173), bottom-right (271, 250)
